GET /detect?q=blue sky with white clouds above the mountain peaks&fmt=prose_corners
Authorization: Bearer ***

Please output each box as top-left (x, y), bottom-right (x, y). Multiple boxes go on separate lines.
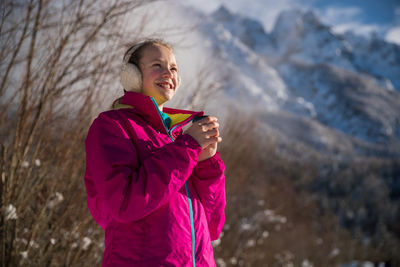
top-left (181, 0), bottom-right (400, 45)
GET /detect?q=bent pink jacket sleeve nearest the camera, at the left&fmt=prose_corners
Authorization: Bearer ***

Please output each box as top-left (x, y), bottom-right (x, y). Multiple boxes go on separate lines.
top-left (85, 115), bottom-right (201, 227)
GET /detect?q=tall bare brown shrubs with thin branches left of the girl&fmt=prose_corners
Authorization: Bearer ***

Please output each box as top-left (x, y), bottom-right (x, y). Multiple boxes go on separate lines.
top-left (0, 0), bottom-right (158, 266)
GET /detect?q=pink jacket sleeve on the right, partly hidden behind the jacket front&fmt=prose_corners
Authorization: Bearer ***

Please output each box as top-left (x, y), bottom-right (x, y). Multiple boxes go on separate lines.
top-left (192, 153), bottom-right (226, 240)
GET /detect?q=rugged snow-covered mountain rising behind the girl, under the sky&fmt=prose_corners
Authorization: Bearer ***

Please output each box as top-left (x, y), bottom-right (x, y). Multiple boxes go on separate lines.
top-left (195, 6), bottom-right (400, 159)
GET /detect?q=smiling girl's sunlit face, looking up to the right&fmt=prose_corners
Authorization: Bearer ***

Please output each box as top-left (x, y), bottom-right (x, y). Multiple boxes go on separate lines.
top-left (139, 45), bottom-right (178, 106)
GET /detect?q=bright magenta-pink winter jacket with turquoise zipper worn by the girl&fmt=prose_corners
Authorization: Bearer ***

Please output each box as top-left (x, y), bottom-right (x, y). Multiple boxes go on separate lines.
top-left (85, 92), bottom-right (225, 267)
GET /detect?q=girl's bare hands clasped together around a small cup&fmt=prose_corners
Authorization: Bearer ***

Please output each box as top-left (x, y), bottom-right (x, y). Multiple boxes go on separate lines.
top-left (183, 116), bottom-right (222, 161)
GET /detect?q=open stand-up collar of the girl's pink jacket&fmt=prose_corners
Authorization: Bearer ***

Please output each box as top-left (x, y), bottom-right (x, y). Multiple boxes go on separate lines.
top-left (120, 92), bottom-right (203, 133)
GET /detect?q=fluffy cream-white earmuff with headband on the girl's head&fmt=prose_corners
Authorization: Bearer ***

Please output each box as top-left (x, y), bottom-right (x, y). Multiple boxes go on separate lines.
top-left (120, 43), bottom-right (143, 93)
